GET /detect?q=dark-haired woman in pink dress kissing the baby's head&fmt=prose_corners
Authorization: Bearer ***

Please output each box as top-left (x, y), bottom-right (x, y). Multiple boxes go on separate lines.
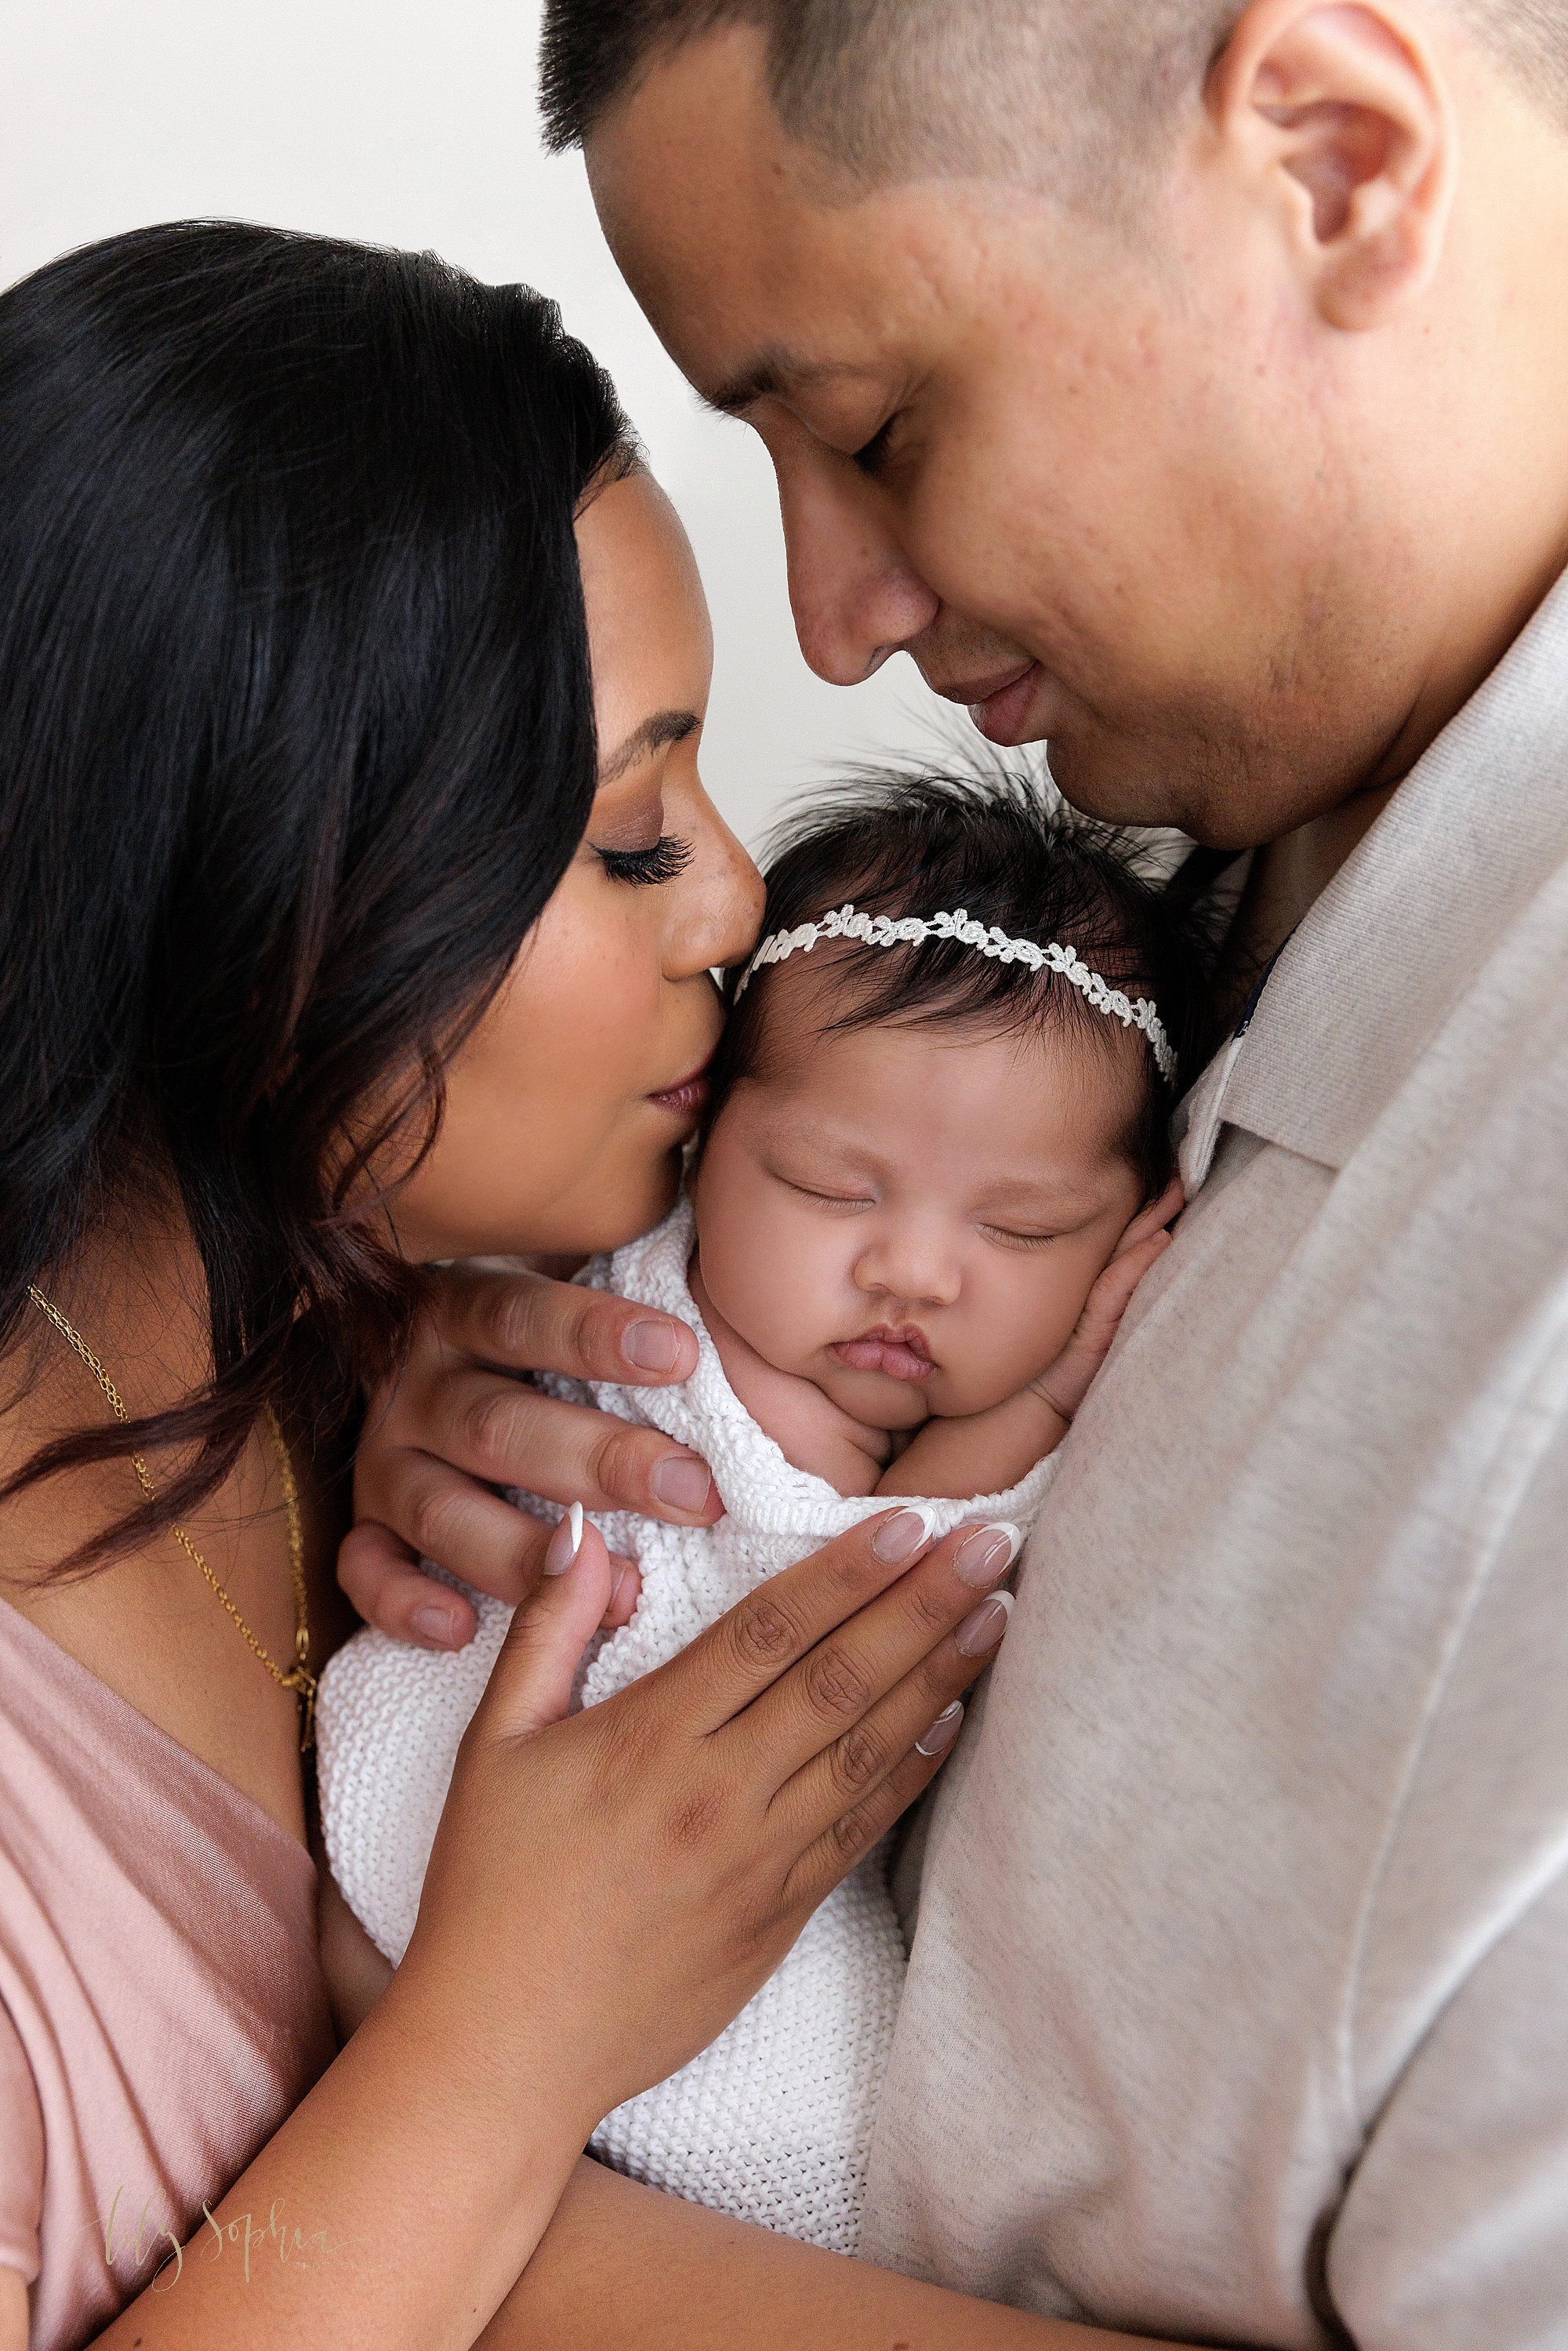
top-left (0, 223), bottom-right (1029, 2351)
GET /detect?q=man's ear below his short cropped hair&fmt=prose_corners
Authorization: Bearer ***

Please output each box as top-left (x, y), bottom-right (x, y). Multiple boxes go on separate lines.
top-left (1206, 0), bottom-right (1457, 332)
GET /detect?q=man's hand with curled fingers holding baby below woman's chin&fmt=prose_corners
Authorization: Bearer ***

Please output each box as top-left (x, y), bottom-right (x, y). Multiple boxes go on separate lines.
top-left (339, 1260), bottom-right (724, 1648)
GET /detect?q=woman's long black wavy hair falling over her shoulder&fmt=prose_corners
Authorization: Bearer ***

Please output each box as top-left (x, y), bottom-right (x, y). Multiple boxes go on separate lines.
top-left (0, 221), bottom-right (633, 1566)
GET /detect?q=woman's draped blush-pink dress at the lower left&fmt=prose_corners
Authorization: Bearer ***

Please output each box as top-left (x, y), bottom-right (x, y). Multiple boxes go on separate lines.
top-left (0, 1601), bottom-right (334, 2351)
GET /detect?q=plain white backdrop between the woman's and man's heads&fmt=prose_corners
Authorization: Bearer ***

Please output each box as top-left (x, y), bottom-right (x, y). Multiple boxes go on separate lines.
top-left (0, 0), bottom-right (926, 840)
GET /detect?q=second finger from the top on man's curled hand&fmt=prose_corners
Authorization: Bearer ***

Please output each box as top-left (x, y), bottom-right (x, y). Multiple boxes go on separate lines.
top-left (368, 1366), bottom-right (724, 1533)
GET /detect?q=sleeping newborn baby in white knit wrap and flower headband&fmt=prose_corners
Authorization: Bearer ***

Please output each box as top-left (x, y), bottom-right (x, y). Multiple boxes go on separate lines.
top-left (318, 776), bottom-right (1199, 2252)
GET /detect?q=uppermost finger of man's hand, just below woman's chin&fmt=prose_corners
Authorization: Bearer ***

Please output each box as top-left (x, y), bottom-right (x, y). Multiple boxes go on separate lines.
top-left (430, 1264), bottom-right (696, 1387)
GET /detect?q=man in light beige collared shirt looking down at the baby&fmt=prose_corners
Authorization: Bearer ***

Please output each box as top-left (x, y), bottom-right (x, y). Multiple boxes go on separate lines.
top-left (350, 0), bottom-right (1568, 2351)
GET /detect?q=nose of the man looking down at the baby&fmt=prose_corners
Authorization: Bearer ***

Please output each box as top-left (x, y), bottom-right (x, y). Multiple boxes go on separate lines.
top-left (769, 426), bottom-right (940, 687)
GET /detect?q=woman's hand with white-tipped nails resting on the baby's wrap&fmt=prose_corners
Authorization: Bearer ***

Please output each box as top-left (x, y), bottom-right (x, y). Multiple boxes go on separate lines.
top-left (399, 1507), bottom-right (1015, 2139)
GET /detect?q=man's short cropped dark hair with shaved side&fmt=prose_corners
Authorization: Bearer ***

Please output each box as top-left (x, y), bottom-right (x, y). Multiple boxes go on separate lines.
top-left (541, 0), bottom-right (1568, 209)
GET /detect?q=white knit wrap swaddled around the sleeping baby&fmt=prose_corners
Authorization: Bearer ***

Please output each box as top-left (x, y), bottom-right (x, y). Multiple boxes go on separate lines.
top-left (318, 1201), bottom-right (1055, 2252)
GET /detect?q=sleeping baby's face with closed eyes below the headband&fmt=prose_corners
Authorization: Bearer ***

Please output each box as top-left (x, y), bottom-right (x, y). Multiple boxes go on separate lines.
top-left (696, 974), bottom-right (1142, 1429)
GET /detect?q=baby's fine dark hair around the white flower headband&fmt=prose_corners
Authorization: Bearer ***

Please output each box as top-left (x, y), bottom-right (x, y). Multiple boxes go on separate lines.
top-left (708, 767), bottom-right (1213, 1194)
